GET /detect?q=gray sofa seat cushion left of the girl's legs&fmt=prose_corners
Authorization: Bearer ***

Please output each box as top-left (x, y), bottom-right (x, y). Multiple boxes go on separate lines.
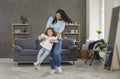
top-left (19, 49), bottom-right (38, 56)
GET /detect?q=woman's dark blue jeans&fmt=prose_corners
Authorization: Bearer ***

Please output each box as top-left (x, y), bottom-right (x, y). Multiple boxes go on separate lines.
top-left (49, 39), bottom-right (62, 69)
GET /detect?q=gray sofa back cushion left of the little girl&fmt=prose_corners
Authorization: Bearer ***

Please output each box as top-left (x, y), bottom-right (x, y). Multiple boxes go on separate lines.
top-left (15, 39), bottom-right (37, 49)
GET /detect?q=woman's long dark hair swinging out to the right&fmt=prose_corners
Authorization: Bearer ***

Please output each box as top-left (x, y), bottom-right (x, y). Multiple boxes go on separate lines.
top-left (52, 9), bottom-right (72, 24)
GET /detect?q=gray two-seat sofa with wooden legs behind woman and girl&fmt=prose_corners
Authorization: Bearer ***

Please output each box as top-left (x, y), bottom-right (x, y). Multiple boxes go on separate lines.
top-left (13, 39), bottom-right (77, 64)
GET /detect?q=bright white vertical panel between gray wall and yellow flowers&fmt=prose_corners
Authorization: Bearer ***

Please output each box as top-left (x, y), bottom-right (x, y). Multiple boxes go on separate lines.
top-left (86, 0), bottom-right (102, 40)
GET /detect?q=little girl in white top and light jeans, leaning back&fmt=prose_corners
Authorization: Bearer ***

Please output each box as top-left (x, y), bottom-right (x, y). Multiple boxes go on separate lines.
top-left (34, 28), bottom-right (58, 69)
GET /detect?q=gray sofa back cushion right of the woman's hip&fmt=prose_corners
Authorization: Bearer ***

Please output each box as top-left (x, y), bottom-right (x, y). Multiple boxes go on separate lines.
top-left (62, 38), bottom-right (75, 49)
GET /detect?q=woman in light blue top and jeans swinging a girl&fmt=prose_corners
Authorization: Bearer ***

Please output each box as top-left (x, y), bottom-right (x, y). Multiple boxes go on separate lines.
top-left (46, 9), bottom-right (72, 74)
